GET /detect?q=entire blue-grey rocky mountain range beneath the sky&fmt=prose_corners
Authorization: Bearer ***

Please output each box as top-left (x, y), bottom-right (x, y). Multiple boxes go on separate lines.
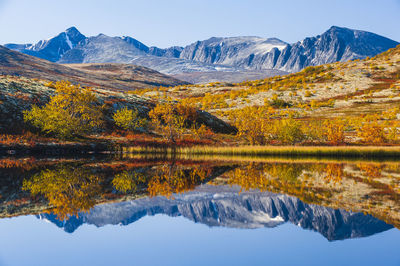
top-left (5, 26), bottom-right (399, 82)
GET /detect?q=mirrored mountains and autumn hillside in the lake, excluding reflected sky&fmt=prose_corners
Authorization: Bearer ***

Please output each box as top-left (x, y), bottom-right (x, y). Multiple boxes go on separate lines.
top-left (0, 155), bottom-right (400, 240)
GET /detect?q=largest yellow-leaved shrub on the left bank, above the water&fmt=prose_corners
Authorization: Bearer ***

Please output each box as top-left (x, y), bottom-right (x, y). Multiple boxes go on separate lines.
top-left (24, 81), bottom-right (103, 139)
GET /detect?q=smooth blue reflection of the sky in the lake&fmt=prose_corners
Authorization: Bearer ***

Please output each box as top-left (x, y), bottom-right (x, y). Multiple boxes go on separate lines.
top-left (0, 215), bottom-right (400, 266)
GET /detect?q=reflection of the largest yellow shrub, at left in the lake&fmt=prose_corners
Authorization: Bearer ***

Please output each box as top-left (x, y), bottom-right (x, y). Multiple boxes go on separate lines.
top-left (23, 166), bottom-right (100, 220)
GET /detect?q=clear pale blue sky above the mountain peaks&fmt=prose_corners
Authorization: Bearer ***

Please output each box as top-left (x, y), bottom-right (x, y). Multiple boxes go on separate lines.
top-left (0, 0), bottom-right (400, 48)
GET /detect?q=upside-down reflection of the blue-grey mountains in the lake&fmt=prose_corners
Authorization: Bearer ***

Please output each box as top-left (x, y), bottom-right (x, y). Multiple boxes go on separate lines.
top-left (38, 185), bottom-right (392, 240)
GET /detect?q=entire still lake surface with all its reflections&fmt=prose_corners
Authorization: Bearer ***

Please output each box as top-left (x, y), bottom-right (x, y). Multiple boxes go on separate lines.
top-left (0, 157), bottom-right (400, 265)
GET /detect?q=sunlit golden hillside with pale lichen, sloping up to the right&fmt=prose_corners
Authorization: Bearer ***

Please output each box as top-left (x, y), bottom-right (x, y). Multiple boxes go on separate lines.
top-left (126, 46), bottom-right (400, 149)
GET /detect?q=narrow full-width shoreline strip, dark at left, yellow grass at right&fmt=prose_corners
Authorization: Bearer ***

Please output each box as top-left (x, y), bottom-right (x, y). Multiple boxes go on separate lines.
top-left (0, 143), bottom-right (400, 160)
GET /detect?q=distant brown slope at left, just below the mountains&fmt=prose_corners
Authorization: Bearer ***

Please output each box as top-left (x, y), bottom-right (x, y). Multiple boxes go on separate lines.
top-left (0, 46), bottom-right (187, 90)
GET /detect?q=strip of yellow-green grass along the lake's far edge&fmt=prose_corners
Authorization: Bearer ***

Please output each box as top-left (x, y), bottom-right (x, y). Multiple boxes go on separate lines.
top-left (122, 146), bottom-right (400, 159)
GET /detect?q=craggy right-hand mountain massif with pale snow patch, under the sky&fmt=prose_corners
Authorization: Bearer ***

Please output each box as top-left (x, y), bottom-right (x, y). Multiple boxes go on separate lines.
top-left (180, 26), bottom-right (398, 72)
